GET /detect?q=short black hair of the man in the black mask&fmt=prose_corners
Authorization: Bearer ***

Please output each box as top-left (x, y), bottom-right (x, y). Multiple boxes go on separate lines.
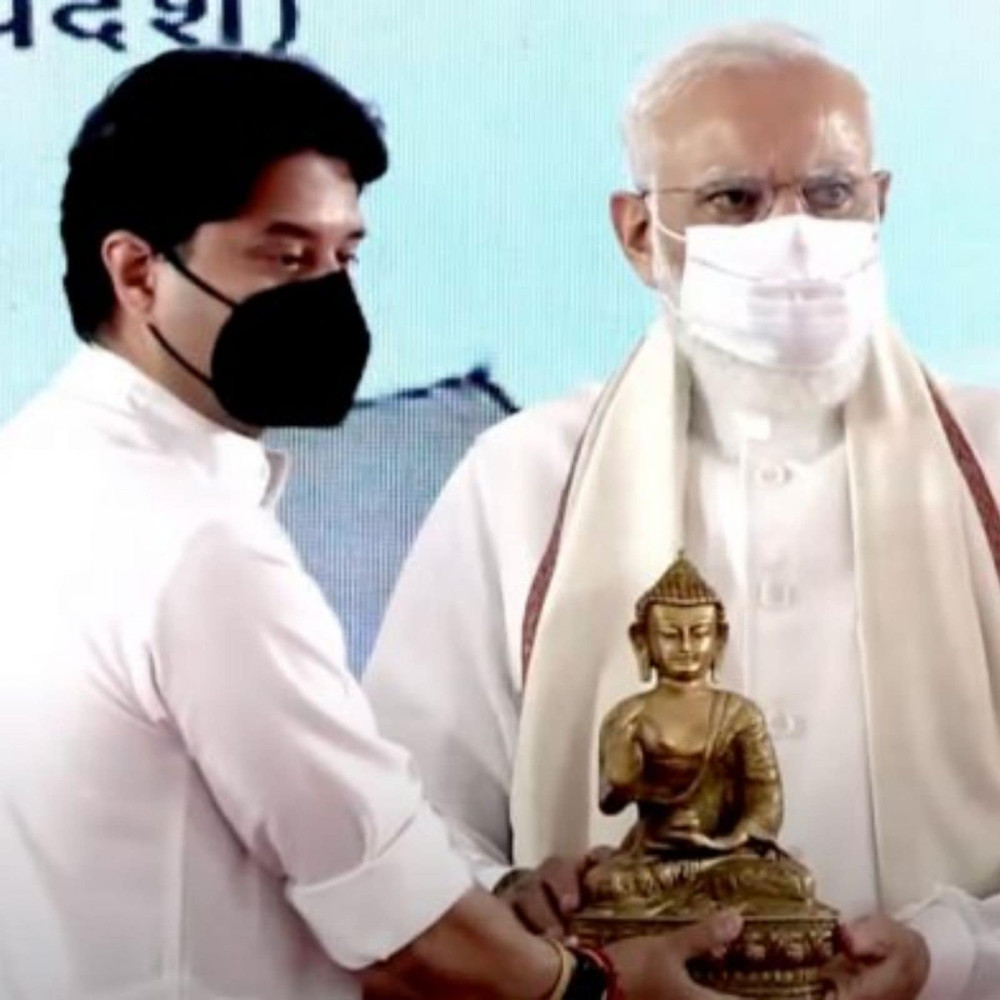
top-left (60, 49), bottom-right (388, 341)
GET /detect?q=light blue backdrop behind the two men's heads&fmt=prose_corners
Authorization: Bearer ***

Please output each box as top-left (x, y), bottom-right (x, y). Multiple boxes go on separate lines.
top-left (0, 0), bottom-right (1000, 418)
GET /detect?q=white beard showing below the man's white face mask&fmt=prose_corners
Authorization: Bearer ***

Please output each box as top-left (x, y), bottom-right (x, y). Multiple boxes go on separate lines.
top-left (671, 316), bottom-right (871, 417)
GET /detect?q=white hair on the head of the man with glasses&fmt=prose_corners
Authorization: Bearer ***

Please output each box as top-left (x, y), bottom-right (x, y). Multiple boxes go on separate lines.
top-left (622, 21), bottom-right (867, 187)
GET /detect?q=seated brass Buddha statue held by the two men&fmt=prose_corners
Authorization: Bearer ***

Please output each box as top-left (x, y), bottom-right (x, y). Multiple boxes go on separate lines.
top-left (573, 554), bottom-right (836, 998)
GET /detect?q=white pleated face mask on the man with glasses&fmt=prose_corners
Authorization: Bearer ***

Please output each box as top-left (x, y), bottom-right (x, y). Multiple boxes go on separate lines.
top-left (654, 210), bottom-right (888, 371)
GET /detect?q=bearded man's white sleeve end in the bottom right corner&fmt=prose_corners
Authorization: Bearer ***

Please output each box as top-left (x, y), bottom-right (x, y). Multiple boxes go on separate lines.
top-left (901, 888), bottom-right (1000, 1000)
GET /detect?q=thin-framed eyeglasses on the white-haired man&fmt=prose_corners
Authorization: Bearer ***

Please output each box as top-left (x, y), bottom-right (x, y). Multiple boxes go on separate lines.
top-left (639, 170), bottom-right (889, 226)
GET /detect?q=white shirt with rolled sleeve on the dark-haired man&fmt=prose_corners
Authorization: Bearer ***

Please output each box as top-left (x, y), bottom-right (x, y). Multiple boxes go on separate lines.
top-left (0, 348), bottom-right (472, 1000)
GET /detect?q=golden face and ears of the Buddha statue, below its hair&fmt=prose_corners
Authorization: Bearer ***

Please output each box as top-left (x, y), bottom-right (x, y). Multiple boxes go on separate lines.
top-left (632, 604), bottom-right (721, 683)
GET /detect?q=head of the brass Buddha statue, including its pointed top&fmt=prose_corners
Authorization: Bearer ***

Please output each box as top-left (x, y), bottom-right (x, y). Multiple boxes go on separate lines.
top-left (629, 552), bottom-right (729, 684)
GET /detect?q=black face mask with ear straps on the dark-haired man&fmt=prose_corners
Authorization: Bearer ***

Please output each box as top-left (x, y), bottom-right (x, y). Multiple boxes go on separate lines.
top-left (149, 252), bottom-right (371, 427)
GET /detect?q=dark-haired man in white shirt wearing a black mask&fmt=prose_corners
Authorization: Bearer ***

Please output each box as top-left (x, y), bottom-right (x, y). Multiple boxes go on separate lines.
top-left (0, 51), bottom-right (739, 1000)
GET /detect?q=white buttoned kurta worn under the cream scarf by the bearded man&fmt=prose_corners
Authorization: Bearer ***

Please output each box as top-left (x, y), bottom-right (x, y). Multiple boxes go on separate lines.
top-left (365, 376), bottom-right (1000, 1000)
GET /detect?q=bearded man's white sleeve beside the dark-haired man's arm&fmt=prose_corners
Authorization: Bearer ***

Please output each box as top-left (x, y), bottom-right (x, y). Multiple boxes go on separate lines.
top-left (363, 458), bottom-right (521, 889)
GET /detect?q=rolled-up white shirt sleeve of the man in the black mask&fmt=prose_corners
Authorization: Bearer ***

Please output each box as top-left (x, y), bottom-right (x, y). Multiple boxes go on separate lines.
top-left (151, 511), bottom-right (472, 969)
